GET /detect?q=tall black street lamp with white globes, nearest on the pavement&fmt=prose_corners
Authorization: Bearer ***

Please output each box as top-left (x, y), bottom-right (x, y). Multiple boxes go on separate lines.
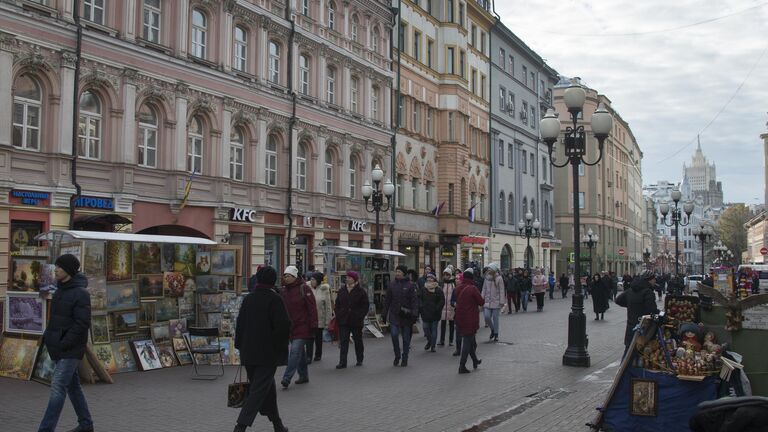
top-left (539, 82), bottom-right (613, 367)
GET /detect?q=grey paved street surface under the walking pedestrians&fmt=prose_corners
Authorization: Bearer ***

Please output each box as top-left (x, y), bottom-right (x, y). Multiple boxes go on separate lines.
top-left (0, 298), bottom-right (656, 432)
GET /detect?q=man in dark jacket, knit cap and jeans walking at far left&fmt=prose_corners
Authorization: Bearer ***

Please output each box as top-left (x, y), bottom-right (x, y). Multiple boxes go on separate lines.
top-left (38, 254), bottom-right (93, 432)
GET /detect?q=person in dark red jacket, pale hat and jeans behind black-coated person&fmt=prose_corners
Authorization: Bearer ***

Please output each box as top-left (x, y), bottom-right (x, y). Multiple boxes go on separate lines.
top-left (280, 266), bottom-right (317, 388)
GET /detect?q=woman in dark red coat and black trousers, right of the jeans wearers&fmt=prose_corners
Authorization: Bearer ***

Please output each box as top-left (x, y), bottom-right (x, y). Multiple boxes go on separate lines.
top-left (454, 269), bottom-right (485, 374)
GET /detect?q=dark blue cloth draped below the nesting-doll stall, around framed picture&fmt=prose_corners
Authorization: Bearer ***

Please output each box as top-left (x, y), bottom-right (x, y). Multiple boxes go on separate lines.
top-left (603, 368), bottom-right (717, 432)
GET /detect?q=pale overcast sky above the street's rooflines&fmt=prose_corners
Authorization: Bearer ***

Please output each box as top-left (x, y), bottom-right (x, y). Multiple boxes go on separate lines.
top-left (496, 0), bottom-right (768, 204)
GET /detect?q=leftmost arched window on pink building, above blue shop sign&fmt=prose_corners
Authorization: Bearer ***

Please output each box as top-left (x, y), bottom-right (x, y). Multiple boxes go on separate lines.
top-left (13, 75), bottom-right (43, 150)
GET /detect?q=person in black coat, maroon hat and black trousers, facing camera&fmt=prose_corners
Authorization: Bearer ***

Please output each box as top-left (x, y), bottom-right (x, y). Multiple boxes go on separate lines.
top-left (336, 271), bottom-right (369, 369)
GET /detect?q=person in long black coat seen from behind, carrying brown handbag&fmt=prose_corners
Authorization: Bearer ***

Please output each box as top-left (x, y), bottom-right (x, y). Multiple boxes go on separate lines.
top-left (235, 266), bottom-right (291, 432)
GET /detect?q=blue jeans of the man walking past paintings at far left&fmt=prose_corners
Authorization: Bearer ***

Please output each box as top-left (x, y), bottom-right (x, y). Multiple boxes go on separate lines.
top-left (38, 359), bottom-right (93, 432)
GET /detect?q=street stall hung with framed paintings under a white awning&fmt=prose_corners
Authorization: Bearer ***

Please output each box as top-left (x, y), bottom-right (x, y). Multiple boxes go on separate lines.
top-left (0, 230), bottom-right (242, 382)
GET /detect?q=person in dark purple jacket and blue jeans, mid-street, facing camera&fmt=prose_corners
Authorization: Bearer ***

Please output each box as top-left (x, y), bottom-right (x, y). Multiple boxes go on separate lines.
top-left (384, 265), bottom-right (419, 367)
